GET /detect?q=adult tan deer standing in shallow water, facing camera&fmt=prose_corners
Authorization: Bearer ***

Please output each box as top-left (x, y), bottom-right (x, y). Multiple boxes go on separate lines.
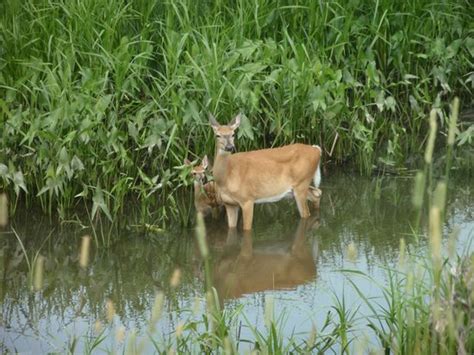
top-left (209, 115), bottom-right (321, 230)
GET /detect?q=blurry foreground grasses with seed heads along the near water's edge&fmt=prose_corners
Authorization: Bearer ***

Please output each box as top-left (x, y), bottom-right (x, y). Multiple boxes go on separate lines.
top-left (0, 96), bottom-right (474, 354)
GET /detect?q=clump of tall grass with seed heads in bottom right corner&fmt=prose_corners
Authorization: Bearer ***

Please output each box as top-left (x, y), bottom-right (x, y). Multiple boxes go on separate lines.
top-left (350, 99), bottom-right (474, 354)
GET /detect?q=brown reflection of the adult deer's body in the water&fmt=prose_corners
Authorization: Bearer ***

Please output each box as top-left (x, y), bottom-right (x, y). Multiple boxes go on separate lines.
top-left (213, 217), bottom-right (319, 300)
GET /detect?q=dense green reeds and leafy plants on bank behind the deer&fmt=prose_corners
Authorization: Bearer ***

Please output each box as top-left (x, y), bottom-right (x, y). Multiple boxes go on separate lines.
top-left (0, 0), bottom-right (474, 224)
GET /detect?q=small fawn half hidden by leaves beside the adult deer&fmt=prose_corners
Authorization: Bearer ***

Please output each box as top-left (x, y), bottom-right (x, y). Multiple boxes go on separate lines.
top-left (184, 155), bottom-right (223, 216)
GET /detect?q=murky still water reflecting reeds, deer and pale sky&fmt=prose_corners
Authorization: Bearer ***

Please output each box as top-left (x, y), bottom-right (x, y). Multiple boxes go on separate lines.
top-left (0, 175), bottom-right (474, 353)
